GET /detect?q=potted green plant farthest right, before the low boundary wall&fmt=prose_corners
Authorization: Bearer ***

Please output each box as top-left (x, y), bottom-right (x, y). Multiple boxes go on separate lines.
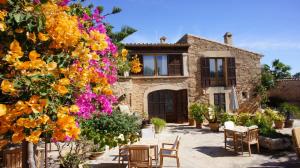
top-left (280, 103), bottom-right (300, 128)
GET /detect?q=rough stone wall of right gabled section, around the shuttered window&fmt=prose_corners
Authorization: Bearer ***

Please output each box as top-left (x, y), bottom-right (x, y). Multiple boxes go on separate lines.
top-left (179, 35), bottom-right (261, 111)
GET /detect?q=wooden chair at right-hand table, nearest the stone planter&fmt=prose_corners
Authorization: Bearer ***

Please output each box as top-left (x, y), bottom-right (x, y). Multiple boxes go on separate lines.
top-left (237, 126), bottom-right (259, 156)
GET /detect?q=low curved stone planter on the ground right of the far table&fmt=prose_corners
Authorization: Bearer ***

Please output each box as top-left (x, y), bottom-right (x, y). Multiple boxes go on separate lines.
top-left (258, 136), bottom-right (292, 150)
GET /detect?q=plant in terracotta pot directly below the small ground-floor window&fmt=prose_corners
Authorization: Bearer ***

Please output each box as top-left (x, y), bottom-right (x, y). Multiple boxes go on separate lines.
top-left (204, 106), bottom-right (222, 132)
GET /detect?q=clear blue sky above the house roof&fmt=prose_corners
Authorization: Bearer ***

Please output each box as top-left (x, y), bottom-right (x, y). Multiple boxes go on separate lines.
top-left (86, 0), bottom-right (300, 73)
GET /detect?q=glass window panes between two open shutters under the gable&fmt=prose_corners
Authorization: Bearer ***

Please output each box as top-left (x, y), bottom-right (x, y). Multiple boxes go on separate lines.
top-left (209, 58), bottom-right (225, 86)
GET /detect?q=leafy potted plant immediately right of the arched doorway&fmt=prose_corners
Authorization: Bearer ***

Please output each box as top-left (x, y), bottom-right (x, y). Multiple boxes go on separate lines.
top-left (189, 103), bottom-right (208, 128)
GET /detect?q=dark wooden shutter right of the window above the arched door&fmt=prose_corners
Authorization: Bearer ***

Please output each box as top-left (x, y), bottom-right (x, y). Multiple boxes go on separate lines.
top-left (168, 55), bottom-right (182, 76)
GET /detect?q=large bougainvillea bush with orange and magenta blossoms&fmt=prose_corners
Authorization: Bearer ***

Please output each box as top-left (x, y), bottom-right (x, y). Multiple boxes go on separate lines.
top-left (0, 0), bottom-right (138, 147)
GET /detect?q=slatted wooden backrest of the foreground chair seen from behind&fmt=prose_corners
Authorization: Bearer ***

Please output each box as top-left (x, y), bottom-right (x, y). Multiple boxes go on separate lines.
top-left (128, 145), bottom-right (150, 163)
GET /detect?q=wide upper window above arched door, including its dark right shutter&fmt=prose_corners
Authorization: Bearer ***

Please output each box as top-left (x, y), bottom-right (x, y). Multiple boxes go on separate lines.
top-left (134, 54), bottom-right (182, 76)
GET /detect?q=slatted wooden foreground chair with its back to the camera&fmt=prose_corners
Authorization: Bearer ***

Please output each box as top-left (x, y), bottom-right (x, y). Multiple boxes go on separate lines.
top-left (128, 145), bottom-right (152, 168)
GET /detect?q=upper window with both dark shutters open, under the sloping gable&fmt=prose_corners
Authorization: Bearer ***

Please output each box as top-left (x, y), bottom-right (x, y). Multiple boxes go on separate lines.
top-left (200, 57), bottom-right (236, 87)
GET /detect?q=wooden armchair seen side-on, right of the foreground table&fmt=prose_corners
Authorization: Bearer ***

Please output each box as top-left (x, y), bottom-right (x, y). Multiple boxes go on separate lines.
top-left (160, 136), bottom-right (180, 167)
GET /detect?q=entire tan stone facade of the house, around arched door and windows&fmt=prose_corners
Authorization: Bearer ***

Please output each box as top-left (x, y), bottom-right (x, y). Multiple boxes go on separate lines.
top-left (115, 34), bottom-right (261, 118)
